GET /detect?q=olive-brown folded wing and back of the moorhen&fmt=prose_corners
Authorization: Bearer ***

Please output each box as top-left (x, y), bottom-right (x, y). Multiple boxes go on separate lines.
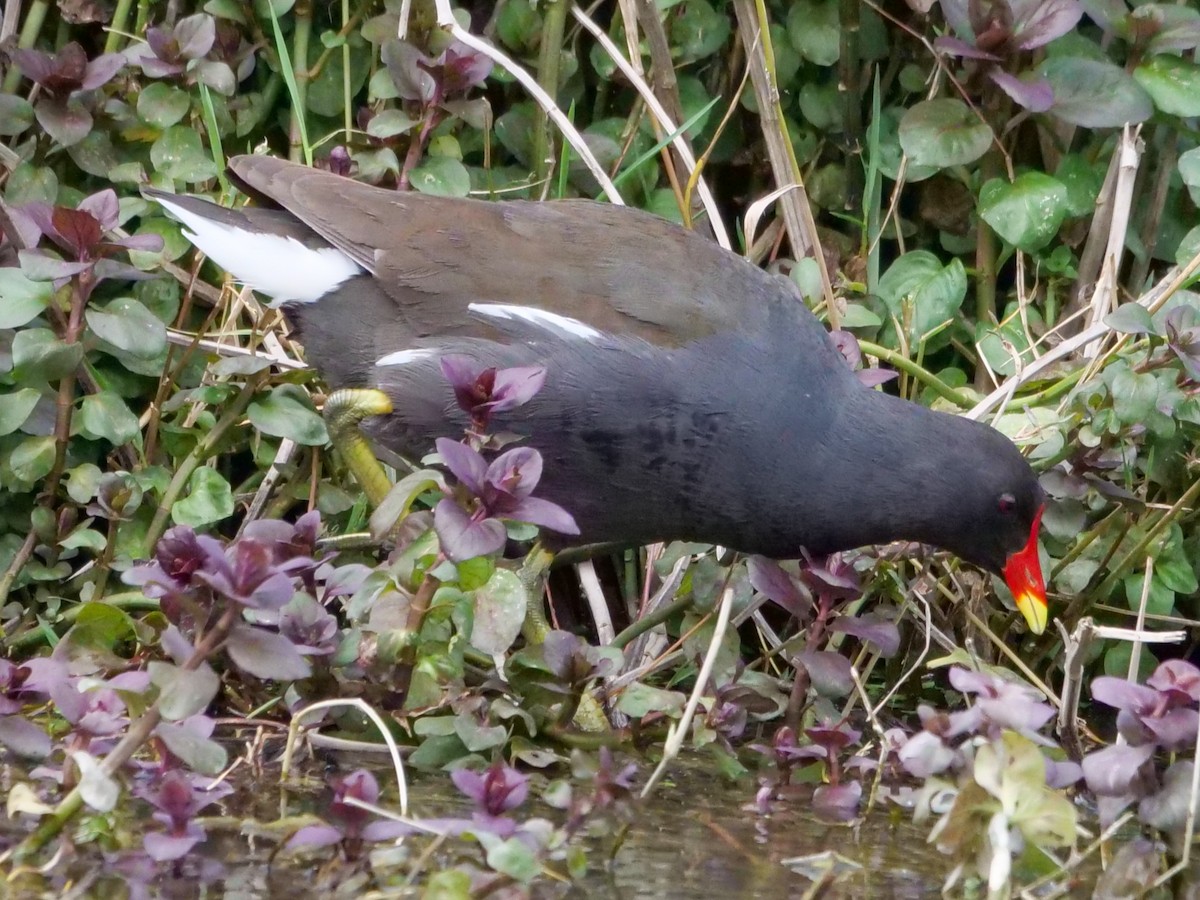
top-left (229, 156), bottom-right (796, 346)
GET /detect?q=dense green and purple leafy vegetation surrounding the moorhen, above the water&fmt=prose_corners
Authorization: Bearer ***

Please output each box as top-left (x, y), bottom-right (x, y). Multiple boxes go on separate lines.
top-left (0, 0), bottom-right (1200, 896)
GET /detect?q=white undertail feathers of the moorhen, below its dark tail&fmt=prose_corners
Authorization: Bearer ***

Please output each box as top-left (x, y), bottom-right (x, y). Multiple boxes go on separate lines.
top-left (155, 198), bottom-right (365, 304)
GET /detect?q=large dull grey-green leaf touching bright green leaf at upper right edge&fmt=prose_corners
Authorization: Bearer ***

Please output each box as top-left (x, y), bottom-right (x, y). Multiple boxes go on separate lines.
top-left (1038, 56), bottom-right (1154, 128)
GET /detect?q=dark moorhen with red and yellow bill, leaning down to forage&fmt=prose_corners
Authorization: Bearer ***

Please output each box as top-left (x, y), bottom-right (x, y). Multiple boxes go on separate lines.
top-left (146, 156), bottom-right (1046, 634)
